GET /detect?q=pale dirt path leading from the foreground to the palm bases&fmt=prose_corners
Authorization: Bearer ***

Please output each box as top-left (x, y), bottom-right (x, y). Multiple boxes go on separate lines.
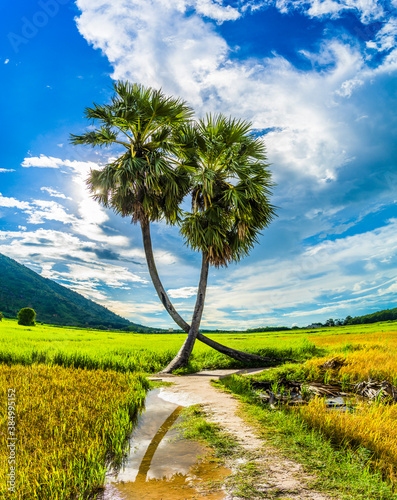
top-left (152, 369), bottom-right (335, 500)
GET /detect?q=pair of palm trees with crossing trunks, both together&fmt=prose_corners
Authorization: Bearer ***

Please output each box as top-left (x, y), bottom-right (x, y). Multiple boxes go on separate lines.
top-left (71, 82), bottom-right (274, 372)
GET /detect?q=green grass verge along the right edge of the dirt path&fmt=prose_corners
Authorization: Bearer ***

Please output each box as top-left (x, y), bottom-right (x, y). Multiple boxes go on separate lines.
top-left (217, 376), bottom-right (397, 500)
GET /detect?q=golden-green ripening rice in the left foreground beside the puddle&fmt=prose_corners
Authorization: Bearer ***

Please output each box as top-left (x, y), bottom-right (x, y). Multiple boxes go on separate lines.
top-left (0, 365), bottom-right (147, 500)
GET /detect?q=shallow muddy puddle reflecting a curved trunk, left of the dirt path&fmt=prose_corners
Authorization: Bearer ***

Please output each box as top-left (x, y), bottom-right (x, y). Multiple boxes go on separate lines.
top-left (100, 389), bottom-right (230, 500)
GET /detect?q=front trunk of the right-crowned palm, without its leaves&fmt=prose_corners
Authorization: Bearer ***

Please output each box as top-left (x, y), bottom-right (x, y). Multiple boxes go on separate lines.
top-left (160, 253), bottom-right (209, 373)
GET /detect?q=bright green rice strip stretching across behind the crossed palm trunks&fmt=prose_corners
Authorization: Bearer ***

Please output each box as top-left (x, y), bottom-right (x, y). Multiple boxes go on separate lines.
top-left (0, 319), bottom-right (397, 373)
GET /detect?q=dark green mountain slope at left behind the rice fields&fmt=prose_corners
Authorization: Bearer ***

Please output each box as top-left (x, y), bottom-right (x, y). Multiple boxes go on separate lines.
top-left (0, 254), bottom-right (153, 332)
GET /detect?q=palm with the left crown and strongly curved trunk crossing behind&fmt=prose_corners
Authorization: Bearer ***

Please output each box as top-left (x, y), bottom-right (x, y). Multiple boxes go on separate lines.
top-left (71, 82), bottom-right (276, 372)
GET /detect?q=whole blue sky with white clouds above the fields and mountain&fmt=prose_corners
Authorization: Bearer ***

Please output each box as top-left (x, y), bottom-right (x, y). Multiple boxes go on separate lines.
top-left (0, 0), bottom-right (397, 329)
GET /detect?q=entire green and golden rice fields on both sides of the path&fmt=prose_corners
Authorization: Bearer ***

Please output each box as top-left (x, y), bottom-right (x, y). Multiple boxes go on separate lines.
top-left (0, 320), bottom-right (397, 500)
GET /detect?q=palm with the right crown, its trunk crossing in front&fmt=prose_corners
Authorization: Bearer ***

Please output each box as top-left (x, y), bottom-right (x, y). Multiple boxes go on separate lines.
top-left (164, 115), bottom-right (275, 372)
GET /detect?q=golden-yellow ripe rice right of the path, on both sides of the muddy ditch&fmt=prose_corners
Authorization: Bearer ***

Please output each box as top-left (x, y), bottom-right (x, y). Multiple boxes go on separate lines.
top-left (299, 331), bottom-right (397, 482)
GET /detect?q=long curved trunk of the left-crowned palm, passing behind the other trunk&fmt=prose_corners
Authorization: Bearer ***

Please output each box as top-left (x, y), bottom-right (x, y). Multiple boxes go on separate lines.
top-left (140, 219), bottom-right (287, 363)
